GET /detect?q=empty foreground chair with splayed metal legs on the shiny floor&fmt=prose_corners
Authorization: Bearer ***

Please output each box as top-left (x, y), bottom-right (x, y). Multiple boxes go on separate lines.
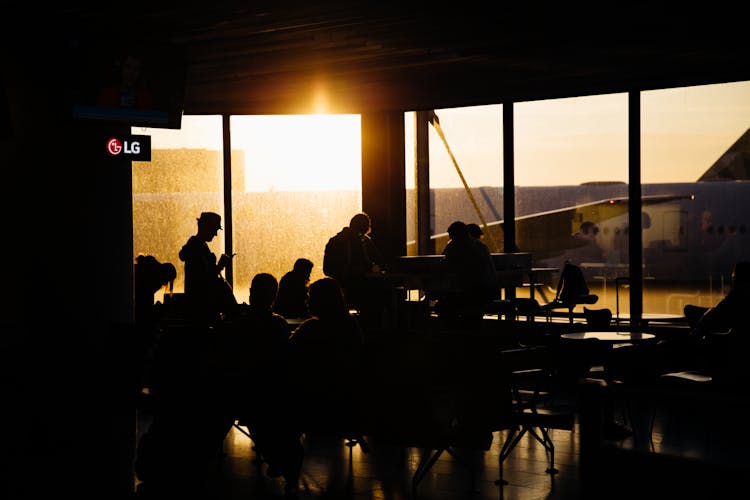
top-left (494, 346), bottom-right (575, 485)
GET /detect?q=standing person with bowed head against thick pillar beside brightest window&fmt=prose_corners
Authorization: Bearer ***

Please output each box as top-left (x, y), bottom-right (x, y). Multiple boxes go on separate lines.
top-left (323, 212), bottom-right (388, 325)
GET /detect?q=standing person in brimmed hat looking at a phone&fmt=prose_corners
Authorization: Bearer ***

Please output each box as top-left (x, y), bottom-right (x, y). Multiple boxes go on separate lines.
top-left (179, 212), bottom-right (237, 323)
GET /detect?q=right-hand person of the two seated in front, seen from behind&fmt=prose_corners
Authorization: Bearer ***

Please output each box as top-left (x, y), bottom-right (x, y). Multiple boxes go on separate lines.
top-left (289, 277), bottom-right (364, 434)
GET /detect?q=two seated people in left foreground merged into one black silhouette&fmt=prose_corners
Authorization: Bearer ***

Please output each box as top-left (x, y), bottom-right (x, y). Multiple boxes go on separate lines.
top-left (136, 270), bottom-right (364, 500)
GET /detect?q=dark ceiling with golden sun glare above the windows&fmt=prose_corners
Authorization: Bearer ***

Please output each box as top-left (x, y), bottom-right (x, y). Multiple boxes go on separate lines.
top-left (15, 1), bottom-right (750, 114)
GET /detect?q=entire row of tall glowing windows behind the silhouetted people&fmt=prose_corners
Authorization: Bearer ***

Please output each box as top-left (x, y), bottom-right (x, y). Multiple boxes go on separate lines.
top-left (133, 82), bottom-right (750, 313)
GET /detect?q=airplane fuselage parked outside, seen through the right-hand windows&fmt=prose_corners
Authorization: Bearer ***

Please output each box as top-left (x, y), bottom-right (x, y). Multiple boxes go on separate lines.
top-left (426, 181), bottom-right (750, 283)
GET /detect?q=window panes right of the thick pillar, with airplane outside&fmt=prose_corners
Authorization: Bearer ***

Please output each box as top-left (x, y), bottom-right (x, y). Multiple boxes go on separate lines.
top-left (406, 82), bottom-right (750, 314)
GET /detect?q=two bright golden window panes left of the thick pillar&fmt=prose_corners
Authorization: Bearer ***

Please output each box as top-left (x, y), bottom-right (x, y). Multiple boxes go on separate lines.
top-left (133, 115), bottom-right (362, 302)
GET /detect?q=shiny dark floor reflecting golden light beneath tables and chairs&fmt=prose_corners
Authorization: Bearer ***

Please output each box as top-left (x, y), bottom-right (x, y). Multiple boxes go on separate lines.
top-left (131, 320), bottom-right (750, 500)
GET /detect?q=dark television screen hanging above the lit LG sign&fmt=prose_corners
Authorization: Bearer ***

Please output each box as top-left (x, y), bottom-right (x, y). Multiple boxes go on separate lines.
top-left (68, 38), bottom-right (186, 129)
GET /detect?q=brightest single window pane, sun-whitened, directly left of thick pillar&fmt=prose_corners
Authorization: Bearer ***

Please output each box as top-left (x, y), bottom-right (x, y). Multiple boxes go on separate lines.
top-left (231, 115), bottom-right (362, 300)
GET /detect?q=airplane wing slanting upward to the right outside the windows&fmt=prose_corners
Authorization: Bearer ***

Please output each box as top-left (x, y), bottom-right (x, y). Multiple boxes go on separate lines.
top-left (432, 195), bottom-right (691, 259)
